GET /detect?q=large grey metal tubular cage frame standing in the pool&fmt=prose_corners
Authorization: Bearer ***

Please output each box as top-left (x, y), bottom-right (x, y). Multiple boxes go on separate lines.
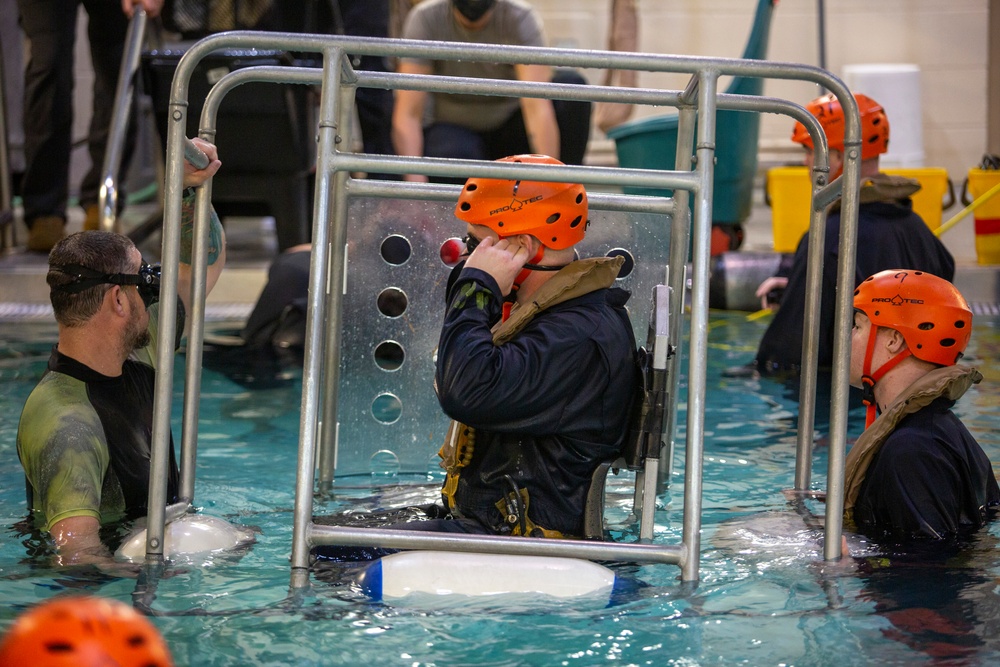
top-left (146, 32), bottom-right (861, 589)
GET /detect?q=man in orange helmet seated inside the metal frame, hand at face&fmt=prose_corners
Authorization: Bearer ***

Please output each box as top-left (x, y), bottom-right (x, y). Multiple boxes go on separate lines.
top-left (314, 155), bottom-right (638, 556)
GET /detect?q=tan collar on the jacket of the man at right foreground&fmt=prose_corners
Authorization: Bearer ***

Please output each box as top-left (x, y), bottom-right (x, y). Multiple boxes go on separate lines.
top-left (844, 365), bottom-right (983, 519)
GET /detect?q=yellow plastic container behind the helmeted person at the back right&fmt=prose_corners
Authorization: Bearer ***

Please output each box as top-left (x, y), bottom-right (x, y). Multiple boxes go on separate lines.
top-left (767, 166), bottom-right (952, 252)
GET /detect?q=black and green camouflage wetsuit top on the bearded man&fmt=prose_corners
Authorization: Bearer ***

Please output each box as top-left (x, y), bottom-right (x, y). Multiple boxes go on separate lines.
top-left (17, 301), bottom-right (184, 530)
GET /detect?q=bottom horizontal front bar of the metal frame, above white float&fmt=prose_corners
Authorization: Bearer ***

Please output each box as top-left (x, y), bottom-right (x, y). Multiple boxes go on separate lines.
top-left (309, 524), bottom-right (683, 565)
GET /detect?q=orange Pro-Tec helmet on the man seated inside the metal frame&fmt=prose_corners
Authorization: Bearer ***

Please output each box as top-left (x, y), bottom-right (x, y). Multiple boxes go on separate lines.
top-left (455, 155), bottom-right (590, 250)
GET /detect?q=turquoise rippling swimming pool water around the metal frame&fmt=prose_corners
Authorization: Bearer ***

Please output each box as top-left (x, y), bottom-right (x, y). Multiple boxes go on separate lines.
top-left (0, 313), bottom-right (1000, 666)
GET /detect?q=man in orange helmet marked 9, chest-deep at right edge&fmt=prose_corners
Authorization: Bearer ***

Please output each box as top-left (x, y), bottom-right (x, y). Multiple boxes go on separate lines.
top-left (844, 269), bottom-right (1000, 541)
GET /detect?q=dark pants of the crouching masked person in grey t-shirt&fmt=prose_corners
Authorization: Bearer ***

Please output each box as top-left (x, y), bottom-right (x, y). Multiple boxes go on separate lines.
top-left (424, 69), bottom-right (592, 184)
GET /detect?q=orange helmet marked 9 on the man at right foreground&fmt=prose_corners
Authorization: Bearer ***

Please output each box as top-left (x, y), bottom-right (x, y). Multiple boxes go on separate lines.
top-left (854, 269), bottom-right (972, 366)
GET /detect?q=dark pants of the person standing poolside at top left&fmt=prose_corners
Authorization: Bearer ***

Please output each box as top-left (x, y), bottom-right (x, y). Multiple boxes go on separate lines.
top-left (17, 0), bottom-right (135, 227)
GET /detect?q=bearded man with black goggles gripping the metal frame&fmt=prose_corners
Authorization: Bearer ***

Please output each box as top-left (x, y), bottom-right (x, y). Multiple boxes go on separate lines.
top-left (17, 139), bottom-right (226, 564)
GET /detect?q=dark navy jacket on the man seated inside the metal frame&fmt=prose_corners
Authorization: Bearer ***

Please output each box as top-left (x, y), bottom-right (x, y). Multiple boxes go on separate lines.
top-left (436, 269), bottom-right (636, 536)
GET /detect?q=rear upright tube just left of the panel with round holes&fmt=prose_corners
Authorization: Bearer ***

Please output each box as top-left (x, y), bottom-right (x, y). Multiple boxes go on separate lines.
top-left (319, 58), bottom-right (355, 491)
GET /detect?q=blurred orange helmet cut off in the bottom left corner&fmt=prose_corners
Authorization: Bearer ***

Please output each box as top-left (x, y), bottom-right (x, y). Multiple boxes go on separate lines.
top-left (0, 596), bottom-right (174, 667)
